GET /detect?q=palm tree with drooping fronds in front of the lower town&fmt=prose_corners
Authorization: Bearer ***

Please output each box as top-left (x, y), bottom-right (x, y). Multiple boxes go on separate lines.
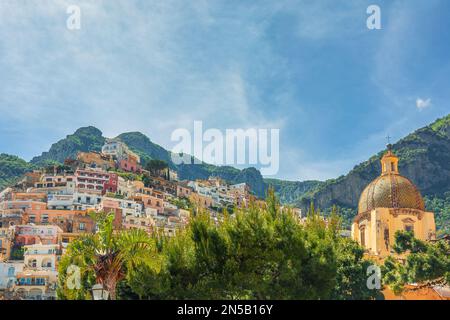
top-left (60, 213), bottom-right (158, 300)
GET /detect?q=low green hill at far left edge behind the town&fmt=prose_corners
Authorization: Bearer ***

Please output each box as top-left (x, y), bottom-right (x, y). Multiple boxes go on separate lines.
top-left (0, 153), bottom-right (33, 191)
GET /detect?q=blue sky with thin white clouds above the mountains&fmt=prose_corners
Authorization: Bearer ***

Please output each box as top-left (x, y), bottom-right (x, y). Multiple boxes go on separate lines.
top-left (0, 0), bottom-right (450, 180)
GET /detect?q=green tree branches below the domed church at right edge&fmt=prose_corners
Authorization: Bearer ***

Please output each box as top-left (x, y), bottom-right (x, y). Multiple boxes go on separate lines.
top-left (382, 231), bottom-right (450, 294)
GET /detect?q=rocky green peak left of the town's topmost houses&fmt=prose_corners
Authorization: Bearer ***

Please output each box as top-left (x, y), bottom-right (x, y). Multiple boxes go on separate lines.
top-left (30, 126), bottom-right (105, 166)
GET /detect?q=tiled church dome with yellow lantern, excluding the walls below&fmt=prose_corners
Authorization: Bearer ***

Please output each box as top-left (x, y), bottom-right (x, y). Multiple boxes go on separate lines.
top-left (358, 146), bottom-right (425, 213)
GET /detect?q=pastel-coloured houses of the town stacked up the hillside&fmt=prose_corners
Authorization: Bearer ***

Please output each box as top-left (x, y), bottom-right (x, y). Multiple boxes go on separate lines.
top-left (0, 139), bottom-right (268, 300)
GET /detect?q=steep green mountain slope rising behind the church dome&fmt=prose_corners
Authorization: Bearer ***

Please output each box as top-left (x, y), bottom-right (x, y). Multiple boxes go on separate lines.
top-left (295, 114), bottom-right (450, 218)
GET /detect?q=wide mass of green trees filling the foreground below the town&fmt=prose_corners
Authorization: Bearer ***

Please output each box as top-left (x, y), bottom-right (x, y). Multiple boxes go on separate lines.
top-left (60, 192), bottom-right (379, 299)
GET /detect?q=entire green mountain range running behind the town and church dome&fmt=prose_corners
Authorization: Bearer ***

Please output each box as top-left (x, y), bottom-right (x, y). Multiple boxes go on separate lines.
top-left (0, 115), bottom-right (450, 224)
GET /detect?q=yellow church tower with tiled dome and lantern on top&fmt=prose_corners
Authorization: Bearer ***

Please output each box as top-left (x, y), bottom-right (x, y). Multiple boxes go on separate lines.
top-left (352, 145), bottom-right (436, 257)
